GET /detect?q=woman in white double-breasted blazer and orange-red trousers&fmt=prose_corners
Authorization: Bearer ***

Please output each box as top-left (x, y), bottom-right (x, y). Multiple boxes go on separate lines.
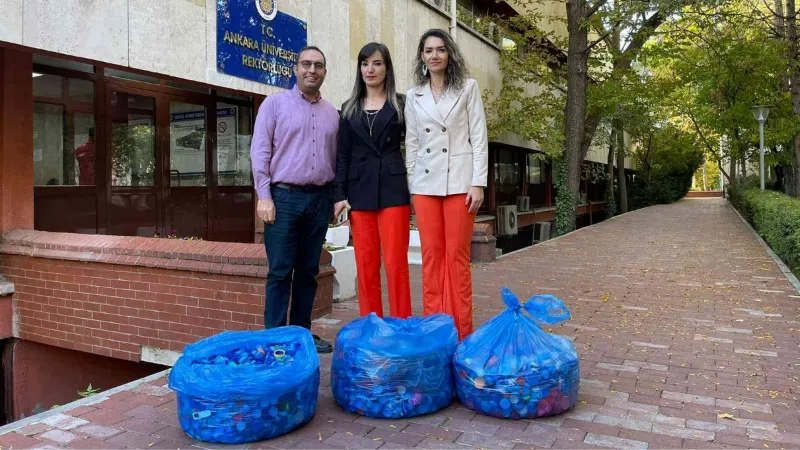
top-left (405, 29), bottom-right (489, 339)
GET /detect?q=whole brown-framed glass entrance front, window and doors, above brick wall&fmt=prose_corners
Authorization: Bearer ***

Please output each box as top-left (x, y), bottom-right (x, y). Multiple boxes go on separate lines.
top-left (34, 58), bottom-right (255, 246)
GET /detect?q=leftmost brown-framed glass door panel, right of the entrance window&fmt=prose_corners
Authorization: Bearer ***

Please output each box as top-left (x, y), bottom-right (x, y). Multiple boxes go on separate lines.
top-left (106, 86), bottom-right (163, 237)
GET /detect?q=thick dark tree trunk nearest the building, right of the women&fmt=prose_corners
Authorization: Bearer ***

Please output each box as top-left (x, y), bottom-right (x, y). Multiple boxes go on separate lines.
top-left (556, 0), bottom-right (589, 235)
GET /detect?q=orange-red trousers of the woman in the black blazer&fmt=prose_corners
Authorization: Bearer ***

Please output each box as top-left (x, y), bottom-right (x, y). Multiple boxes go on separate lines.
top-left (350, 206), bottom-right (411, 319)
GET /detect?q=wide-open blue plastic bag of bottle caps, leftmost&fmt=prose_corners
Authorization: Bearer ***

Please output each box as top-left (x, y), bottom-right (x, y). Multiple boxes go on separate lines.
top-left (169, 326), bottom-right (319, 444)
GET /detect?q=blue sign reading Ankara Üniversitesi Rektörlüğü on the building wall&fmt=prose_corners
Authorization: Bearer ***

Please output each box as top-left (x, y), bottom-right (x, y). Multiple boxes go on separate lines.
top-left (217, 0), bottom-right (308, 89)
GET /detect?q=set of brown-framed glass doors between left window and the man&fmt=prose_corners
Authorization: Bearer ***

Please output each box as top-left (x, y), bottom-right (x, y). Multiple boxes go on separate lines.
top-left (102, 82), bottom-right (255, 242)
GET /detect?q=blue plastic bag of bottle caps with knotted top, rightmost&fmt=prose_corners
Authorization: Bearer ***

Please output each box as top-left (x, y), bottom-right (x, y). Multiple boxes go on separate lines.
top-left (454, 288), bottom-right (580, 419)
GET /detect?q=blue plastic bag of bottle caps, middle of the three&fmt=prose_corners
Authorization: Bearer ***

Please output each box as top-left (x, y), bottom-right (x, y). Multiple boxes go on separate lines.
top-left (331, 313), bottom-right (458, 419)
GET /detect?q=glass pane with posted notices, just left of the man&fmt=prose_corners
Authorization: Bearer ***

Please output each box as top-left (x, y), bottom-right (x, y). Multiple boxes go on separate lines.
top-left (216, 102), bottom-right (253, 186)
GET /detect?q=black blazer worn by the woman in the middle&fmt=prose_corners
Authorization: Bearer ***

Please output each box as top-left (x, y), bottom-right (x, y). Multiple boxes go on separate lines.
top-left (334, 98), bottom-right (411, 211)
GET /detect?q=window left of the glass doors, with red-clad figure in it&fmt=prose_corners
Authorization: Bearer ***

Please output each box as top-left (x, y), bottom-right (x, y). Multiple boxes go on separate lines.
top-left (33, 72), bottom-right (96, 186)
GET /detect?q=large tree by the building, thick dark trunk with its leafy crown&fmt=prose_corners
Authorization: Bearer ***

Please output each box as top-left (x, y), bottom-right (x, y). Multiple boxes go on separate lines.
top-left (490, 0), bottom-right (689, 234)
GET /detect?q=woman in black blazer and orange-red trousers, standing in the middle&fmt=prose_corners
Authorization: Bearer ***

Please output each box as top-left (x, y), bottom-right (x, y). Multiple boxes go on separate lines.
top-left (335, 42), bottom-right (411, 319)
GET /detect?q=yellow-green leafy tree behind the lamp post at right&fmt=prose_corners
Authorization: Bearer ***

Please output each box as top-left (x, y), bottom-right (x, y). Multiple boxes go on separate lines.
top-left (641, 1), bottom-right (793, 187)
